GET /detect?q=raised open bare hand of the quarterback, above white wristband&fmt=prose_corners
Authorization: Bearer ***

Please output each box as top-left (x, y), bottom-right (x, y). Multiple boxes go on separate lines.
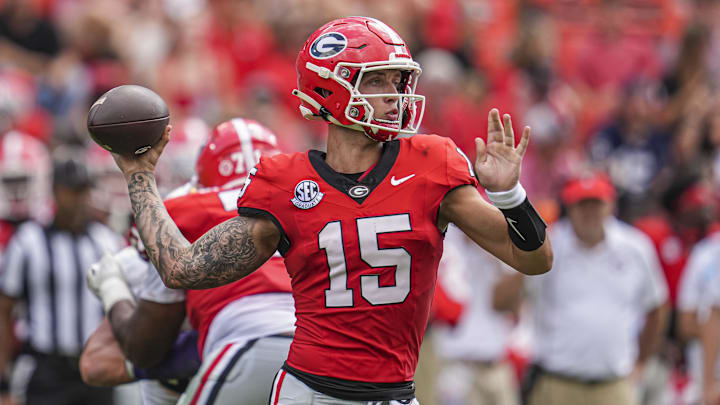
top-left (475, 108), bottom-right (530, 192)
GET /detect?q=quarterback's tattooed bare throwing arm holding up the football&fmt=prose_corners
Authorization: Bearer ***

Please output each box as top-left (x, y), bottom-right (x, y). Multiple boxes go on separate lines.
top-left (113, 126), bottom-right (280, 289)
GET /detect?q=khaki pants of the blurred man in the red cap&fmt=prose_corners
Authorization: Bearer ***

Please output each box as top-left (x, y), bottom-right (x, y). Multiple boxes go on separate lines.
top-left (529, 374), bottom-right (637, 405)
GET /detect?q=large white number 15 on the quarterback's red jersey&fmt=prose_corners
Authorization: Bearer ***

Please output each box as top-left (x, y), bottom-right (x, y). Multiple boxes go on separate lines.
top-left (318, 214), bottom-right (412, 308)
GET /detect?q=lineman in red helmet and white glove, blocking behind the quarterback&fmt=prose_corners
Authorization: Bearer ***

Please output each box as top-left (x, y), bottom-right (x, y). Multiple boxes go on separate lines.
top-left (81, 118), bottom-right (295, 405)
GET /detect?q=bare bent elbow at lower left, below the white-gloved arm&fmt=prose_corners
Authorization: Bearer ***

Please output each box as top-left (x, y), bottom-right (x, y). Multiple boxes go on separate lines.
top-left (80, 319), bottom-right (133, 387)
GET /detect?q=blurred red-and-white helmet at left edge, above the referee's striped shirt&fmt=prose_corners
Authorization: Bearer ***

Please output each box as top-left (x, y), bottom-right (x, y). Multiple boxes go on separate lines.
top-left (0, 131), bottom-right (52, 220)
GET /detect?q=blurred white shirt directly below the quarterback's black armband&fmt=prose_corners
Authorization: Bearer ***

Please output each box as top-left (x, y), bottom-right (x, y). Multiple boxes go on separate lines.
top-left (433, 225), bottom-right (513, 361)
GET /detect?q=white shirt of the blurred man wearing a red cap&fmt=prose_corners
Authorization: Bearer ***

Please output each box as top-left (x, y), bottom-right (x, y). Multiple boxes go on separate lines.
top-left (527, 219), bottom-right (668, 379)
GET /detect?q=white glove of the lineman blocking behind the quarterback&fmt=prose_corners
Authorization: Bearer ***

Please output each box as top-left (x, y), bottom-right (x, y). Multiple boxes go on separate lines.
top-left (86, 252), bottom-right (135, 313)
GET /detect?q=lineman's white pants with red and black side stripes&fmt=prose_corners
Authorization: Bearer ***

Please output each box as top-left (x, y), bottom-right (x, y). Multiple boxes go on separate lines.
top-left (178, 336), bottom-right (292, 405)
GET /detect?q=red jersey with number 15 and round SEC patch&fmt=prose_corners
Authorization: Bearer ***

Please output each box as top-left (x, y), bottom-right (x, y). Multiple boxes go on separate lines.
top-left (238, 135), bottom-right (477, 383)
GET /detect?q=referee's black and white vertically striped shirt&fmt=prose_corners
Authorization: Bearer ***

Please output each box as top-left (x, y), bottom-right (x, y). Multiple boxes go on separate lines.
top-left (0, 221), bottom-right (122, 356)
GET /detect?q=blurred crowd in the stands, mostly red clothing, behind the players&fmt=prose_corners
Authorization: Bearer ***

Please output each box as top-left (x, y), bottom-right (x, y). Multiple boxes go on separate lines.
top-left (0, 0), bottom-right (720, 403)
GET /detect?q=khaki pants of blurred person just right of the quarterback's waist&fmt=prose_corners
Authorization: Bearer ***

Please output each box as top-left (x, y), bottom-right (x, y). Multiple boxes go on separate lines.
top-left (436, 361), bottom-right (520, 405)
